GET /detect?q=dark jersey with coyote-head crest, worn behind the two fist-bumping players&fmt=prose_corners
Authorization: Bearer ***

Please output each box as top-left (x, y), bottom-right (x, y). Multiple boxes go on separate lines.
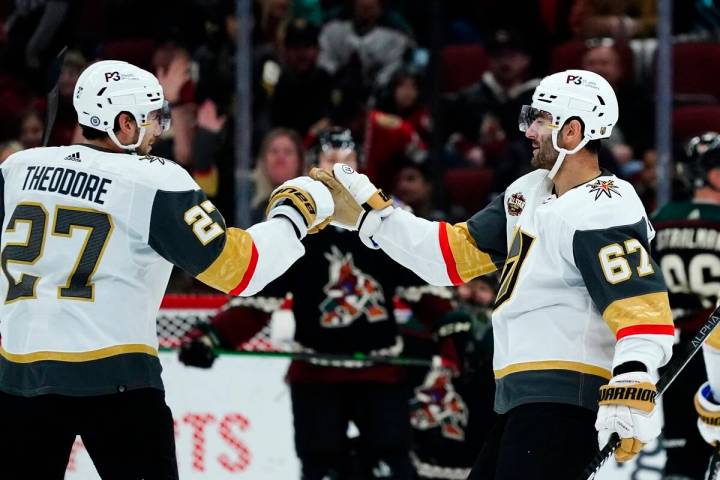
top-left (212, 227), bottom-right (452, 381)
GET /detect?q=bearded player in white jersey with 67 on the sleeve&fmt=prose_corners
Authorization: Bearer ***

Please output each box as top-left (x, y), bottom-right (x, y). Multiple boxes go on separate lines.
top-left (311, 70), bottom-right (674, 480)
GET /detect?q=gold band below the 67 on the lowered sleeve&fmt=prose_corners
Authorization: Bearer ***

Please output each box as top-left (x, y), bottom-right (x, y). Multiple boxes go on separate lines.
top-left (603, 292), bottom-right (673, 335)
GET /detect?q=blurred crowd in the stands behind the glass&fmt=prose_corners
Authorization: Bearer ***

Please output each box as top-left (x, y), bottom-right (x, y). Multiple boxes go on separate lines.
top-left (0, 0), bottom-right (720, 238)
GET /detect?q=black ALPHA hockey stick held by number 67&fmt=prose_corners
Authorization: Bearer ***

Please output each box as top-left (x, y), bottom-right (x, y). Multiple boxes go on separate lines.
top-left (578, 306), bottom-right (720, 480)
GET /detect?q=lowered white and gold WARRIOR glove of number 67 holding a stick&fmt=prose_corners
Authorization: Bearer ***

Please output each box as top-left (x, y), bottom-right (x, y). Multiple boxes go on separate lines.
top-left (595, 372), bottom-right (660, 463)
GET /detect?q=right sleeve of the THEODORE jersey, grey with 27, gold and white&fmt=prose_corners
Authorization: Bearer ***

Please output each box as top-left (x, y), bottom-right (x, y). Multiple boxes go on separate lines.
top-left (135, 158), bottom-right (305, 296)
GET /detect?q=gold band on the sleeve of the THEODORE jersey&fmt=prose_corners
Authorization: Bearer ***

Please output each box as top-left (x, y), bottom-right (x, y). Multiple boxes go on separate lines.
top-left (197, 228), bottom-right (253, 293)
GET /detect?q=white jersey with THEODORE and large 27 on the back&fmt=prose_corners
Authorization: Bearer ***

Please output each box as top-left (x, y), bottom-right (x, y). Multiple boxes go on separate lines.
top-left (0, 145), bottom-right (304, 396)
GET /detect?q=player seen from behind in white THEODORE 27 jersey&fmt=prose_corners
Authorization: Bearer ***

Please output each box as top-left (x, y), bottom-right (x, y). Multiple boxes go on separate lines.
top-left (0, 61), bottom-right (333, 480)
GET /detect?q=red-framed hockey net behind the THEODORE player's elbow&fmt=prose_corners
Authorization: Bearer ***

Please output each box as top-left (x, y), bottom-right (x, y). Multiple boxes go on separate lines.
top-left (157, 293), bottom-right (291, 352)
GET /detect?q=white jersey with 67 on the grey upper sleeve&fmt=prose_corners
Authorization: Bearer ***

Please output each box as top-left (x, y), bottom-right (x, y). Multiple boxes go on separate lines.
top-left (373, 170), bottom-right (674, 413)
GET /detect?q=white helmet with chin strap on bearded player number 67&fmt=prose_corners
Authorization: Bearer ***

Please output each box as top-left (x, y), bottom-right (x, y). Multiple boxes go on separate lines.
top-left (519, 70), bottom-right (619, 178)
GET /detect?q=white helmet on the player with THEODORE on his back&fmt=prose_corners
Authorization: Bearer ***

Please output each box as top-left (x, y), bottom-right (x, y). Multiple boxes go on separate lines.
top-left (73, 60), bottom-right (170, 150)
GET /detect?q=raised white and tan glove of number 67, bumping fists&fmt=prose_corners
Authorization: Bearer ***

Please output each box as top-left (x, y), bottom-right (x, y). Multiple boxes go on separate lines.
top-left (310, 163), bottom-right (393, 248)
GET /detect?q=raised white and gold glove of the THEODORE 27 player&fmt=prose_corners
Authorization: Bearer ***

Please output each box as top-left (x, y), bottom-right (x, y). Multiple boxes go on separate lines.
top-left (266, 177), bottom-right (335, 239)
